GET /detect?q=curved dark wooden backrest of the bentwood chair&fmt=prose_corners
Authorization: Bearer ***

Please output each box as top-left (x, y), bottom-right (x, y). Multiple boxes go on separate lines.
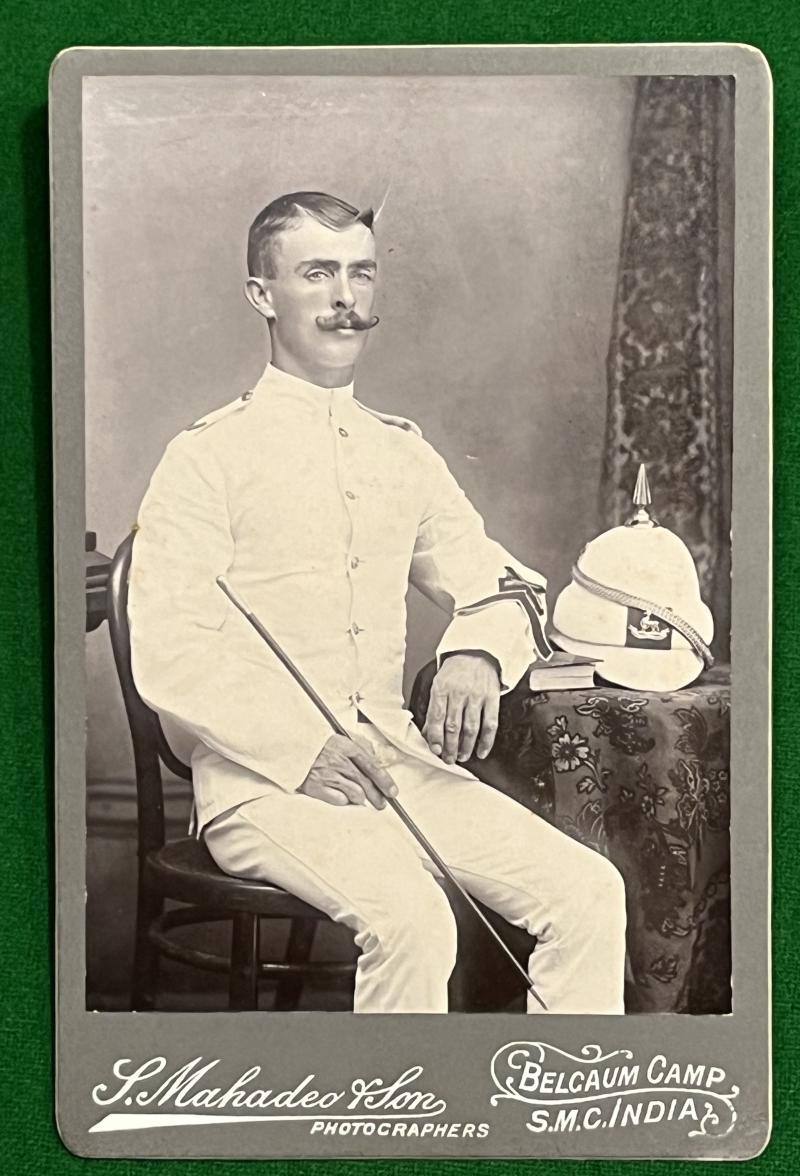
top-left (106, 532), bottom-right (192, 855)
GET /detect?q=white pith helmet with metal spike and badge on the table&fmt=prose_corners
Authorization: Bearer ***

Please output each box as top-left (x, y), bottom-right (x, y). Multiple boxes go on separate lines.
top-left (553, 466), bottom-right (714, 691)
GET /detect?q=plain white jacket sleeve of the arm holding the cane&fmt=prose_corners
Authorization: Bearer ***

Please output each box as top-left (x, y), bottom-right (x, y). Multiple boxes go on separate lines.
top-left (128, 436), bottom-right (331, 791)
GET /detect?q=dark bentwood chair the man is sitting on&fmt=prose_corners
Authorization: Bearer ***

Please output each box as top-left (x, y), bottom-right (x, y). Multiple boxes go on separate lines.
top-left (107, 534), bottom-right (354, 1010)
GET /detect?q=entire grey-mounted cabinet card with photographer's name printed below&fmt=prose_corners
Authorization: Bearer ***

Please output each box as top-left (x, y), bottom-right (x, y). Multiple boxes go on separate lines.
top-left (51, 45), bottom-right (772, 1158)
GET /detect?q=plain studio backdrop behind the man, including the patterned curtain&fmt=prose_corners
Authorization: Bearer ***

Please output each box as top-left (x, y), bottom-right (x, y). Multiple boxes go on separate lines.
top-left (84, 76), bottom-right (733, 1007)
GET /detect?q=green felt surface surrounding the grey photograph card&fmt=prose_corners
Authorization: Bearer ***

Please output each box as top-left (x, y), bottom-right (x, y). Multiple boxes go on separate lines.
top-left (0, 0), bottom-right (785, 1176)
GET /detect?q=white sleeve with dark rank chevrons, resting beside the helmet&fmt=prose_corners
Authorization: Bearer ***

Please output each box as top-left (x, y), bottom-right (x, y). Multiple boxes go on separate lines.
top-left (411, 442), bottom-right (552, 690)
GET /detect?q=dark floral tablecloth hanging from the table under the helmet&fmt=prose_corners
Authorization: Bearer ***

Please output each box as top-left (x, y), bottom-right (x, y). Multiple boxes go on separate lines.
top-left (411, 666), bottom-right (731, 1014)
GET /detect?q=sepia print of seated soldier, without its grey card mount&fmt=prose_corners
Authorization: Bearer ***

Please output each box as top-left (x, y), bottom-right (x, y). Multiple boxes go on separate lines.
top-left (82, 74), bottom-right (734, 1015)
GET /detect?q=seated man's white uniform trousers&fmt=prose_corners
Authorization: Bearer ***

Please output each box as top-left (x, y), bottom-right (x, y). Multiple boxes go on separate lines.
top-left (204, 724), bottom-right (626, 1014)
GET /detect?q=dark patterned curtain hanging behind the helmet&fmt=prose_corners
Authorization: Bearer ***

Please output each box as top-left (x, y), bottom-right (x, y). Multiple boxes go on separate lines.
top-left (601, 78), bottom-right (733, 657)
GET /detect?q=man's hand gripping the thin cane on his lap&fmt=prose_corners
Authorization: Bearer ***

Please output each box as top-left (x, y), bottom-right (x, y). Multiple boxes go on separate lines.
top-left (298, 735), bottom-right (398, 809)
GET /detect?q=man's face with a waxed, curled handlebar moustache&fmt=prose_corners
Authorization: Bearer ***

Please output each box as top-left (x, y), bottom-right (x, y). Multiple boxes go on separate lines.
top-left (258, 216), bottom-right (376, 372)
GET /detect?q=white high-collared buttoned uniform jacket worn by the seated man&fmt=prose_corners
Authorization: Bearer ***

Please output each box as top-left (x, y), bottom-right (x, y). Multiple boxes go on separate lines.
top-left (128, 366), bottom-right (549, 827)
